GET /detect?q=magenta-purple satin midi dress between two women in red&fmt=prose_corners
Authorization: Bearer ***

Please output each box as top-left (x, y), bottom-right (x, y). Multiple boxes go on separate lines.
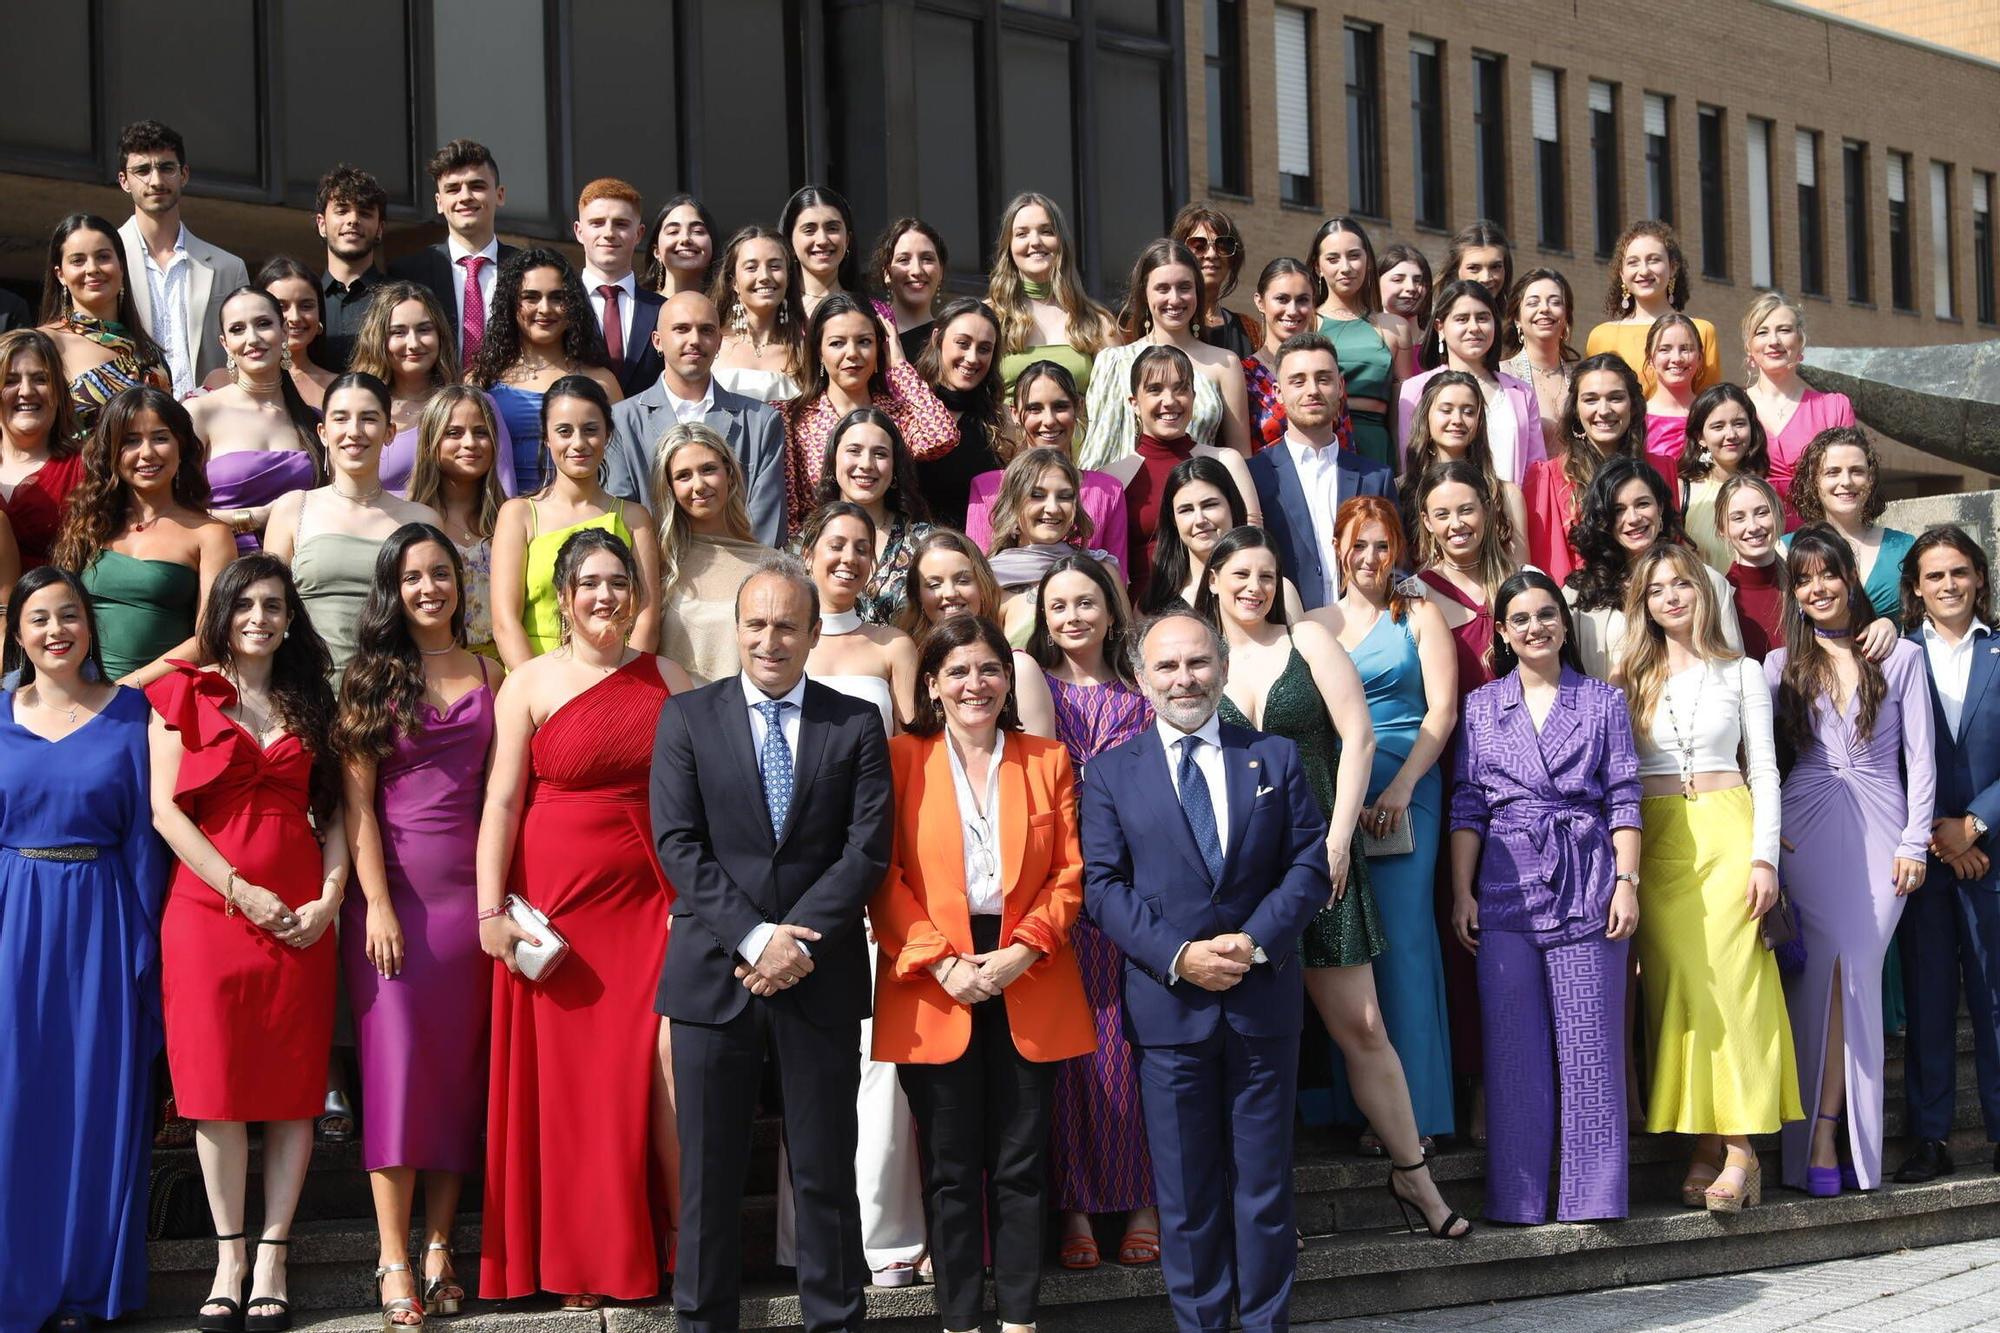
top-left (340, 685), bottom-right (494, 1171)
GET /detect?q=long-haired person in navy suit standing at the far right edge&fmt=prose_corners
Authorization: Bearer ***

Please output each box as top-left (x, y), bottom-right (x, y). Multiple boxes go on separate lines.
top-left (1896, 524), bottom-right (2000, 1183)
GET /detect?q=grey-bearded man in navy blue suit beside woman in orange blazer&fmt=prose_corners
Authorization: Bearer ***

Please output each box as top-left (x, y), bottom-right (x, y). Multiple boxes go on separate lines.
top-left (1080, 610), bottom-right (1330, 1331)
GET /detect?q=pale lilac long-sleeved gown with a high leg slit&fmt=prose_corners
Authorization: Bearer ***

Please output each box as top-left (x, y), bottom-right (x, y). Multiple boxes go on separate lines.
top-left (1764, 638), bottom-right (1936, 1189)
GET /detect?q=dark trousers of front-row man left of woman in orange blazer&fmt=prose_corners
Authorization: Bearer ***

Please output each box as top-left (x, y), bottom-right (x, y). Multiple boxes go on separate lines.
top-left (672, 999), bottom-right (868, 1333)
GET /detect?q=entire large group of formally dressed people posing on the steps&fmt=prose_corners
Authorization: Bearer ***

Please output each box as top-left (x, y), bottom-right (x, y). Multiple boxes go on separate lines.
top-left (0, 122), bottom-right (2000, 1333)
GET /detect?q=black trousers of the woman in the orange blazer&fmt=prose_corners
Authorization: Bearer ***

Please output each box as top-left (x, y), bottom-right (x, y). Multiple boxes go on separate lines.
top-left (904, 917), bottom-right (1056, 1329)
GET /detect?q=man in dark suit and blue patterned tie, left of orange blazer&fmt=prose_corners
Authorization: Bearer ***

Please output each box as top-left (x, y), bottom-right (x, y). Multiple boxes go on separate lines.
top-left (652, 556), bottom-right (892, 1333)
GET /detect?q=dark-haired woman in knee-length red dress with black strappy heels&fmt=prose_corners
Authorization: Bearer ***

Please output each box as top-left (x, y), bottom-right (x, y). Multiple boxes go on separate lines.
top-left (146, 552), bottom-right (348, 1333)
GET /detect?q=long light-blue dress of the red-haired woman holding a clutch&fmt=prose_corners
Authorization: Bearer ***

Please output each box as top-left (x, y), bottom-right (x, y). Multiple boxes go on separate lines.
top-left (1334, 612), bottom-right (1452, 1135)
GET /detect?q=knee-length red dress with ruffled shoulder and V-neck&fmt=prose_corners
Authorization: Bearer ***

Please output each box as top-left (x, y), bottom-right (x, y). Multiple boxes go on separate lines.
top-left (146, 662), bottom-right (338, 1121)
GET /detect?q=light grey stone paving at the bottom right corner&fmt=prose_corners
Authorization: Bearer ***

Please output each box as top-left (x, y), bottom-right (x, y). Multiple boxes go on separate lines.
top-left (1294, 1239), bottom-right (2000, 1333)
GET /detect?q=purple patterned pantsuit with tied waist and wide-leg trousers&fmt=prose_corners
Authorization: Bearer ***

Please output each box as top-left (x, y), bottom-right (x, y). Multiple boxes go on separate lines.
top-left (1450, 669), bottom-right (1640, 1223)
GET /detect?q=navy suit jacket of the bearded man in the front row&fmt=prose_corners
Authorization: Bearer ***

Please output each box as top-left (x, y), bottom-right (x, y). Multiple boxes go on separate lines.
top-left (1078, 725), bottom-right (1332, 1047)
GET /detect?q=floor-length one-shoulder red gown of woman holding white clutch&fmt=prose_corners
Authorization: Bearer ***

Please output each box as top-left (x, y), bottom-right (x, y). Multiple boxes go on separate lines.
top-left (480, 656), bottom-right (672, 1301)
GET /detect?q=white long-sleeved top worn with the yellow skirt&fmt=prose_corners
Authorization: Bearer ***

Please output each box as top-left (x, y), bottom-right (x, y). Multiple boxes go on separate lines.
top-left (1634, 656), bottom-right (1780, 865)
